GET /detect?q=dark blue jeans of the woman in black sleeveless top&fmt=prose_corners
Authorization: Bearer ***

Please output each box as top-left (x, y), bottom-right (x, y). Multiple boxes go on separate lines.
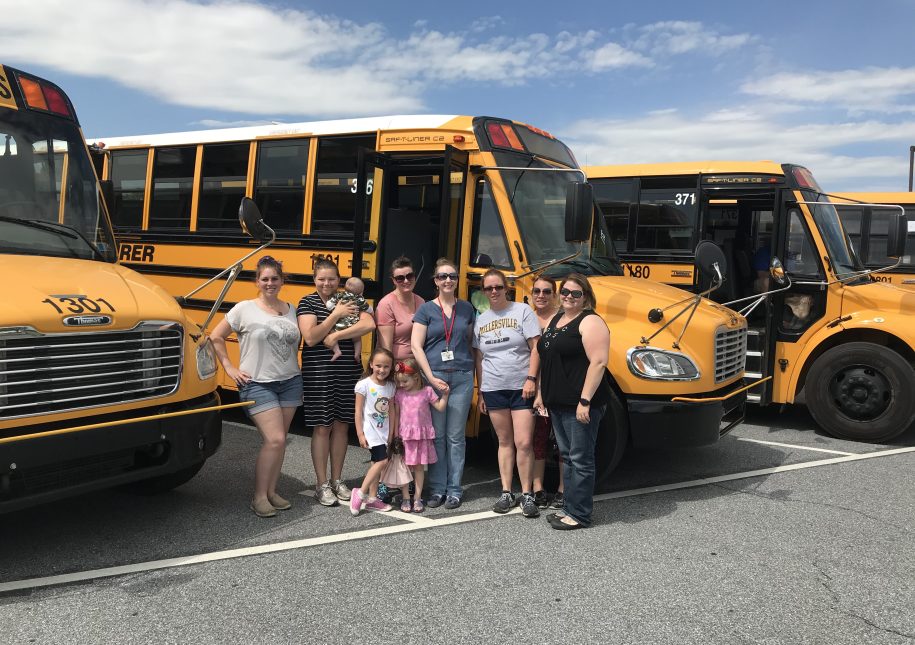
top-left (550, 405), bottom-right (607, 526)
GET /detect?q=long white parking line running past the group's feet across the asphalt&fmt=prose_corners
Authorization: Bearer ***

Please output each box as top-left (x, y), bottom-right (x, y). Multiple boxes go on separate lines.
top-left (0, 446), bottom-right (915, 593)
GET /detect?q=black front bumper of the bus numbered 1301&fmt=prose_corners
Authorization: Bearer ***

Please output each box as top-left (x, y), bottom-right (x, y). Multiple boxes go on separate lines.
top-left (0, 393), bottom-right (222, 513)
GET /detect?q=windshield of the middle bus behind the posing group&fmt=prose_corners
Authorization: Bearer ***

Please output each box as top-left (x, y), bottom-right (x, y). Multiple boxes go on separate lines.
top-left (496, 153), bottom-right (621, 275)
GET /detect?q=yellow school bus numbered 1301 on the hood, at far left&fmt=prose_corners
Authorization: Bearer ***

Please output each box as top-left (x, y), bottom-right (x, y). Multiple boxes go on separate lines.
top-left (0, 66), bottom-right (234, 512)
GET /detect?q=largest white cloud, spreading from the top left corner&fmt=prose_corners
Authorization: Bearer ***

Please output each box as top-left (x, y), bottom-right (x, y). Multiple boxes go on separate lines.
top-left (0, 0), bottom-right (688, 117)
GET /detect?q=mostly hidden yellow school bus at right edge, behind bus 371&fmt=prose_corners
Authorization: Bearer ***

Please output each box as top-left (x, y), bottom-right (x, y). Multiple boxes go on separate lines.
top-left (830, 193), bottom-right (915, 289)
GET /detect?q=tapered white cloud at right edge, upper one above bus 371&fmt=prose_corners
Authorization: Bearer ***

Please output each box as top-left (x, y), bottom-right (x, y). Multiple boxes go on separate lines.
top-left (740, 67), bottom-right (915, 114)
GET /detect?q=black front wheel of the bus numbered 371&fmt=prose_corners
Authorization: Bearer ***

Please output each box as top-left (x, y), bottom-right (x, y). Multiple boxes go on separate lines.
top-left (804, 343), bottom-right (915, 441)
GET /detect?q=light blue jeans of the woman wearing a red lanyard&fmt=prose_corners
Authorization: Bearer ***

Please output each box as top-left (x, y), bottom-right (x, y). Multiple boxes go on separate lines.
top-left (426, 370), bottom-right (473, 497)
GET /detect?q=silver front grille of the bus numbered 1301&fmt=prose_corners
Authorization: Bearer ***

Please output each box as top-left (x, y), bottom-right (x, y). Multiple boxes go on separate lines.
top-left (0, 322), bottom-right (184, 420)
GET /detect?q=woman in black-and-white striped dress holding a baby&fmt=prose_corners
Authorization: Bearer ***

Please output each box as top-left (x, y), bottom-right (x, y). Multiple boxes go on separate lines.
top-left (296, 260), bottom-right (375, 506)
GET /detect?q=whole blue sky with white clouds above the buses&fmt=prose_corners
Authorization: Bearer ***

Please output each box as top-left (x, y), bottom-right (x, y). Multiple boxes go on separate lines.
top-left (0, 0), bottom-right (915, 192)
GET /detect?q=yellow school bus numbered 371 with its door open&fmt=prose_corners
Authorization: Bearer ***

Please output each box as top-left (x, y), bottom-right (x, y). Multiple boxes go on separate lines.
top-left (585, 161), bottom-right (915, 441)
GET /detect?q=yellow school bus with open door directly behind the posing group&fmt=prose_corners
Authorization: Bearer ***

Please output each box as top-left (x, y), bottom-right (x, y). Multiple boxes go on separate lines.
top-left (93, 115), bottom-right (746, 484)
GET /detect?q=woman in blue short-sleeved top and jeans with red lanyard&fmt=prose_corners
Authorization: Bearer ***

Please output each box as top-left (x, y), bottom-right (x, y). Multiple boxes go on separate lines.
top-left (410, 258), bottom-right (474, 509)
